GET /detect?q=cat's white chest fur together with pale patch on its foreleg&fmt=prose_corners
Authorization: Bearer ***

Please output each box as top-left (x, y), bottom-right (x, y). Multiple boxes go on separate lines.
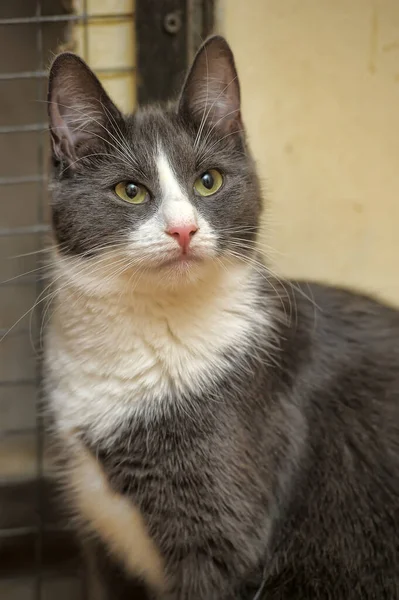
top-left (46, 258), bottom-right (268, 587)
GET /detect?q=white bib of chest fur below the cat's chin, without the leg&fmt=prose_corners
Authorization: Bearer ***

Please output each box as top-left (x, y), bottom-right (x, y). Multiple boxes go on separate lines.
top-left (47, 265), bottom-right (267, 438)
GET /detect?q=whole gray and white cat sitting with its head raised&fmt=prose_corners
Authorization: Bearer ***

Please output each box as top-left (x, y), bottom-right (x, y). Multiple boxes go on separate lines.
top-left (45, 36), bottom-right (399, 600)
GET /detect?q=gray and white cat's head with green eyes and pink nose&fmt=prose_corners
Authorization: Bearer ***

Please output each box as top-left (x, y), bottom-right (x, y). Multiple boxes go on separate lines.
top-left (48, 36), bottom-right (261, 286)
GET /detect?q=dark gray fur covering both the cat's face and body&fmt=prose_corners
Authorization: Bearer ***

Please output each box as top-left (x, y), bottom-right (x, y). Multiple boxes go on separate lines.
top-left (45, 38), bottom-right (399, 600)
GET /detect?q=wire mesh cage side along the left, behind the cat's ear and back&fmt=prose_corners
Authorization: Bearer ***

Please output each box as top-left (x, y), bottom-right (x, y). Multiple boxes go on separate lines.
top-left (0, 0), bottom-right (135, 600)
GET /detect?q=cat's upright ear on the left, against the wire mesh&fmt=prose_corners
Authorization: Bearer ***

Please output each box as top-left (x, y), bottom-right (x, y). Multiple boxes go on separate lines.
top-left (48, 52), bottom-right (120, 163)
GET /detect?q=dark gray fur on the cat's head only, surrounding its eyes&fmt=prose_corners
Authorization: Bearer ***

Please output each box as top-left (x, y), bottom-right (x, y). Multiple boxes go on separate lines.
top-left (49, 40), bottom-right (260, 257)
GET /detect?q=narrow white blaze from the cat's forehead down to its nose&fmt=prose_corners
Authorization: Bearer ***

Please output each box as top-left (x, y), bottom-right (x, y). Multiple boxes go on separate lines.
top-left (157, 148), bottom-right (198, 227)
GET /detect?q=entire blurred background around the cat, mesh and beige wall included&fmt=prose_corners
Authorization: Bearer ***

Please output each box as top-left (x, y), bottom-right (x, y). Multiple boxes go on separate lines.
top-left (0, 0), bottom-right (399, 600)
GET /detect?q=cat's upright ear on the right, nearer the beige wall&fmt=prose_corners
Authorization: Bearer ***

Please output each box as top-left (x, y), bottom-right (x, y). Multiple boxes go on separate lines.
top-left (179, 35), bottom-right (242, 134)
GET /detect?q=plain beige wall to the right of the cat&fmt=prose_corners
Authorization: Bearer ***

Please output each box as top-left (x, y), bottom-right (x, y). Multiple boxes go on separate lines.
top-left (218, 0), bottom-right (399, 304)
